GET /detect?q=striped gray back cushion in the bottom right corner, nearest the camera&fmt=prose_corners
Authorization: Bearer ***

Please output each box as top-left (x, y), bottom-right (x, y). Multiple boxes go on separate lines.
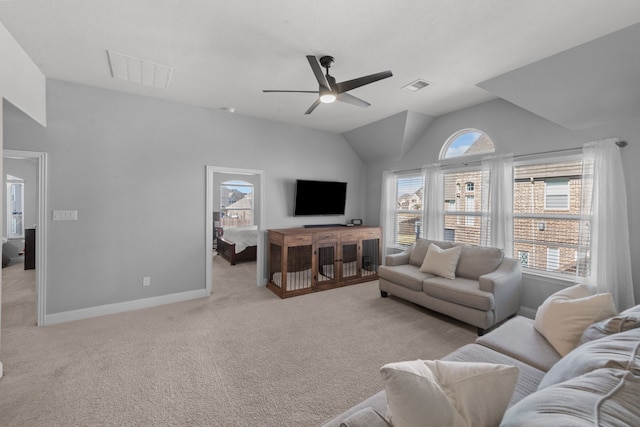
top-left (500, 369), bottom-right (640, 427)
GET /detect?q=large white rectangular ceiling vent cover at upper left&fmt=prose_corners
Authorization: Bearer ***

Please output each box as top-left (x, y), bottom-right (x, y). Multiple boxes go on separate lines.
top-left (107, 50), bottom-right (173, 89)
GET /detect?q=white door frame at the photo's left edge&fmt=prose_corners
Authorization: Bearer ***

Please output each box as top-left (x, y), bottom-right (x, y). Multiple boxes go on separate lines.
top-left (2, 149), bottom-right (48, 326)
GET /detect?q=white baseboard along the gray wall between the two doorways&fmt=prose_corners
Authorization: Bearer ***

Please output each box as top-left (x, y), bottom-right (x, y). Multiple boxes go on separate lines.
top-left (45, 289), bottom-right (210, 326)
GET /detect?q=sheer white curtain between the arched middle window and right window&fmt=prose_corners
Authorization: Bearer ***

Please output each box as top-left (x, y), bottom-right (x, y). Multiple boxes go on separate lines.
top-left (480, 154), bottom-right (513, 257)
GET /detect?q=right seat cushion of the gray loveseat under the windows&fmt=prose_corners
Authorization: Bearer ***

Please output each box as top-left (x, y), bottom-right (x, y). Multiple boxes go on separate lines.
top-left (422, 277), bottom-right (495, 311)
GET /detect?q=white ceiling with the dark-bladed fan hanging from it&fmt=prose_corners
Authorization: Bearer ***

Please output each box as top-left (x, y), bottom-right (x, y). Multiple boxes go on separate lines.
top-left (0, 0), bottom-right (640, 133)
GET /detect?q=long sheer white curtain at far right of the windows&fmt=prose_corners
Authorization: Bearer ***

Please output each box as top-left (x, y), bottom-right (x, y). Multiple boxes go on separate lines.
top-left (578, 138), bottom-right (634, 310)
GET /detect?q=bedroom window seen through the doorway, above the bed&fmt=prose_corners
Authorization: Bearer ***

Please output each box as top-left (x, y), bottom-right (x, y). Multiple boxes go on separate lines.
top-left (220, 181), bottom-right (253, 227)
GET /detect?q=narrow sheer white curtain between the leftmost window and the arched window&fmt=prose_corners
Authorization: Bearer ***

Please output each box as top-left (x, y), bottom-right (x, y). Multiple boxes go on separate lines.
top-left (422, 163), bottom-right (444, 240)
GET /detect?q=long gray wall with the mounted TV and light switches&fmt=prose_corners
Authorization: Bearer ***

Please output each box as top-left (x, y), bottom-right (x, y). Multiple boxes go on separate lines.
top-left (4, 80), bottom-right (365, 314)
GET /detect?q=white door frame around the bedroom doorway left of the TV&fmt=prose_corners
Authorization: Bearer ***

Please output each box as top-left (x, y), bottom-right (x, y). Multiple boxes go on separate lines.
top-left (205, 166), bottom-right (266, 295)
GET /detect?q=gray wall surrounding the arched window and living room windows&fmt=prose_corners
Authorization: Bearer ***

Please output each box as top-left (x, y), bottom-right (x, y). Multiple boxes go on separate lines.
top-left (366, 100), bottom-right (640, 310)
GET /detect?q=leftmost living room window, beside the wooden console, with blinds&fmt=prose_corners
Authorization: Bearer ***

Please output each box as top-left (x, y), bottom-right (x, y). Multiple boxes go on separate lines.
top-left (394, 173), bottom-right (423, 246)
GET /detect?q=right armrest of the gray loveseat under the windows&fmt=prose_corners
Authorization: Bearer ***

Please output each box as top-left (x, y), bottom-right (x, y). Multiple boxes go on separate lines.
top-left (478, 258), bottom-right (522, 323)
